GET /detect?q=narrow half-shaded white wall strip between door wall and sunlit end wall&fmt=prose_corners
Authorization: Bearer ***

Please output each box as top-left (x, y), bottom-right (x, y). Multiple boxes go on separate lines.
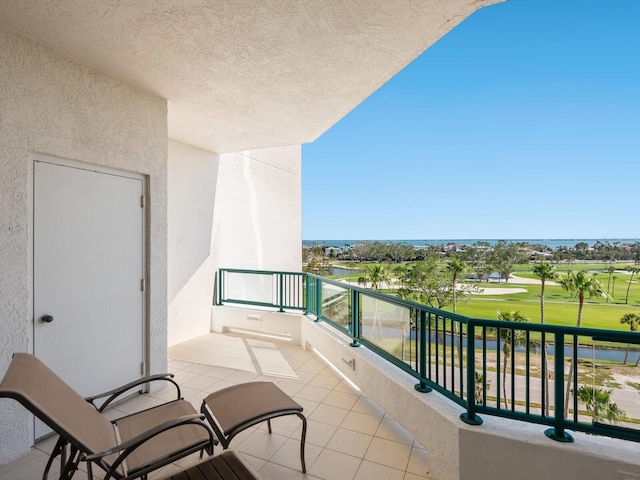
top-left (168, 140), bottom-right (219, 345)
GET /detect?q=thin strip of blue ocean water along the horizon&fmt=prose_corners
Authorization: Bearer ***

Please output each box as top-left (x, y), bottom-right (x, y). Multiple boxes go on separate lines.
top-left (302, 238), bottom-right (640, 249)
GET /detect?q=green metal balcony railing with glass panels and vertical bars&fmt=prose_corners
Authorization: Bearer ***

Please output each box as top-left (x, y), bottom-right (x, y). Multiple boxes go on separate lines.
top-left (216, 269), bottom-right (640, 442)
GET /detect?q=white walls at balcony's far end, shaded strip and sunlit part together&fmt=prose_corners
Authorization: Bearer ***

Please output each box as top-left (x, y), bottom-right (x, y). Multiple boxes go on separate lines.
top-left (168, 141), bottom-right (302, 345)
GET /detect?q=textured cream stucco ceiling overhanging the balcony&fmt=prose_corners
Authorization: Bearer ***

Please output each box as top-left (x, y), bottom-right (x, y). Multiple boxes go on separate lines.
top-left (0, 0), bottom-right (503, 153)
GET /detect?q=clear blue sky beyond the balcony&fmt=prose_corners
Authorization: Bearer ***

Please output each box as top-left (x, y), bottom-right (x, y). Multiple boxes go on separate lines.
top-left (302, 0), bottom-right (640, 240)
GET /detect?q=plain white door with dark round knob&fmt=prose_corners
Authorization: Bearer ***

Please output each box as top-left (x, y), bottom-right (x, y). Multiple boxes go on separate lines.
top-left (33, 158), bottom-right (145, 438)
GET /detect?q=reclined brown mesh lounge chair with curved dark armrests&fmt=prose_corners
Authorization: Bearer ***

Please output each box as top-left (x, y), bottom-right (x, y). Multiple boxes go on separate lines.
top-left (0, 353), bottom-right (217, 480)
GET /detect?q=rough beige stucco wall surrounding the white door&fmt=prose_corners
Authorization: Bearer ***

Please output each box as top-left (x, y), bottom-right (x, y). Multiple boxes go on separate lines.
top-left (0, 29), bottom-right (167, 464)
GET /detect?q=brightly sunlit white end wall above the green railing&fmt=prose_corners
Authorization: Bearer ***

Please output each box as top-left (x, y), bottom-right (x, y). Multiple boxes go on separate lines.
top-left (212, 145), bottom-right (302, 271)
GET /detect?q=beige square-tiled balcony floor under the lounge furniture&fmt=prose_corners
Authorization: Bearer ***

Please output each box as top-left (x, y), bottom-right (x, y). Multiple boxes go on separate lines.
top-left (0, 334), bottom-right (429, 480)
